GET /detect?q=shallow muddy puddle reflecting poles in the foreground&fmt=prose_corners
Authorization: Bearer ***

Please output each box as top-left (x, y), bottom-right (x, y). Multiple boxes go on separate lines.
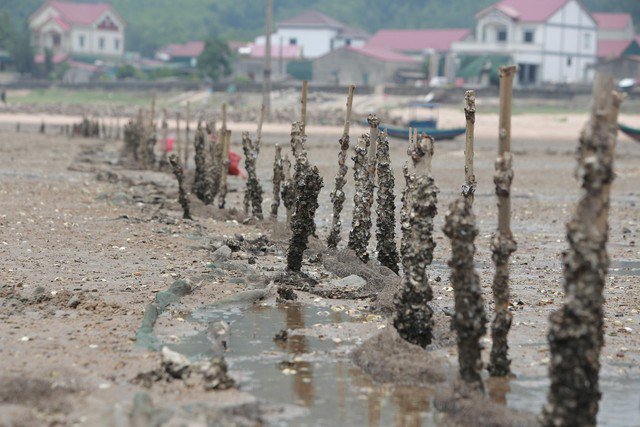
top-left (161, 303), bottom-right (640, 426)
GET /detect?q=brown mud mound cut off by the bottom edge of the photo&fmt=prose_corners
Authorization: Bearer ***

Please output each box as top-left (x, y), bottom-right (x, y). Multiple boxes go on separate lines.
top-left (434, 383), bottom-right (539, 427)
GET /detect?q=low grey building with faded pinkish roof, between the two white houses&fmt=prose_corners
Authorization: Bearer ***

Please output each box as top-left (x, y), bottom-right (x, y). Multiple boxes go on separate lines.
top-left (313, 45), bottom-right (422, 85)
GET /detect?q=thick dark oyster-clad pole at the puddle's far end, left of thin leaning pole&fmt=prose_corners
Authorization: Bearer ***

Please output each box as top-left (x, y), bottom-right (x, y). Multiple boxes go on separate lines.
top-left (287, 122), bottom-right (322, 271)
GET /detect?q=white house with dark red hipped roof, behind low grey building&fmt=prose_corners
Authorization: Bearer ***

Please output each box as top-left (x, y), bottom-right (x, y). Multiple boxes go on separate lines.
top-left (255, 10), bottom-right (369, 58)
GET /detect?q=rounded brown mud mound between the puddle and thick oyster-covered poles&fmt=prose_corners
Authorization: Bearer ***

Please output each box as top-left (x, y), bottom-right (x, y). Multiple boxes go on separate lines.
top-left (351, 326), bottom-right (454, 386)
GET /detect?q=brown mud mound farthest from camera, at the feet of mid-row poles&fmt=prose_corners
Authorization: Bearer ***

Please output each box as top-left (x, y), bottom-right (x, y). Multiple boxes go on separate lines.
top-left (322, 249), bottom-right (400, 295)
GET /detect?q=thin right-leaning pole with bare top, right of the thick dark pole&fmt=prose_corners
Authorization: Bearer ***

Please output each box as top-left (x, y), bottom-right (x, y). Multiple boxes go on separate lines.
top-left (327, 85), bottom-right (356, 249)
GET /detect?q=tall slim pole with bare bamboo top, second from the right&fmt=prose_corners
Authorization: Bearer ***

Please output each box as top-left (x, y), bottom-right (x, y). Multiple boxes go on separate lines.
top-left (488, 65), bottom-right (517, 377)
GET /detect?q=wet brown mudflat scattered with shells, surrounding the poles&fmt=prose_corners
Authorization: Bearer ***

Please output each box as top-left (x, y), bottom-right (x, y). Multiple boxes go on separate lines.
top-left (0, 129), bottom-right (640, 426)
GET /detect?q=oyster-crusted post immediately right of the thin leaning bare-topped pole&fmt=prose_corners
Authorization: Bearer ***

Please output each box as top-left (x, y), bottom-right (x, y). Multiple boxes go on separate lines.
top-left (347, 134), bottom-right (371, 262)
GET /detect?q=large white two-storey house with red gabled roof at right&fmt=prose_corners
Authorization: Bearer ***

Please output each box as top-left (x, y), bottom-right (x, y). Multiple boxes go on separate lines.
top-left (452, 0), bottom-right (598, 86)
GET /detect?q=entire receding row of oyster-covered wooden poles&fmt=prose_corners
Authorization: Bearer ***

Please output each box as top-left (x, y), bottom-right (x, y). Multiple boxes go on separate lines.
top-left (120, 71), bottom-right (622, 426)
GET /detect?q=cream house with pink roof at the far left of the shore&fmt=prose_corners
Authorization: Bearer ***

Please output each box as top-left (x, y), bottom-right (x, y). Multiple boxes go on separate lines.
top-left (29, 0), bottom-right (125, 57)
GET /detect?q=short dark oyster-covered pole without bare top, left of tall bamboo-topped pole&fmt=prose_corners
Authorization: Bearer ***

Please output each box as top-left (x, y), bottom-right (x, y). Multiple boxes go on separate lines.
top-left (444, 195), bottom-right (487, 390)
